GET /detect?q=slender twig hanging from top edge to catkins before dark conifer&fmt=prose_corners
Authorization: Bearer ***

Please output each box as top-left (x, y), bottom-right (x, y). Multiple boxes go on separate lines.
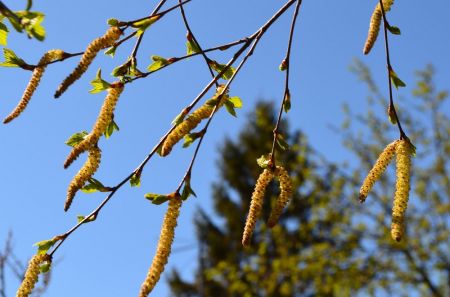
top-left (269, 0), bottom-right (302, 169)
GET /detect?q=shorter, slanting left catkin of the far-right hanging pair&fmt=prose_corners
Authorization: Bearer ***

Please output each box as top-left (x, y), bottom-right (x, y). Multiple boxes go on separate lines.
top-left (359, 140), bottom-right (400, 203)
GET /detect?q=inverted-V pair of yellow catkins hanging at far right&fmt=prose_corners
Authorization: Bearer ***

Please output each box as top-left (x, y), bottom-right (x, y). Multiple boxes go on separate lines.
top-left (359, 138), bottom-right (414, 241)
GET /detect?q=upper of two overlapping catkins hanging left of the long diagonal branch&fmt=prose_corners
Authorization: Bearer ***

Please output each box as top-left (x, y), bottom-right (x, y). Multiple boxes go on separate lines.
top-left (64, 82), bottom-right (124, 168)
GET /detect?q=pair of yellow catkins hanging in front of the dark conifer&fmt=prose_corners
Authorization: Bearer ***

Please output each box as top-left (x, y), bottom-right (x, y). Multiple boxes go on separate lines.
top-left (242, 166), bottom-right (292, 246)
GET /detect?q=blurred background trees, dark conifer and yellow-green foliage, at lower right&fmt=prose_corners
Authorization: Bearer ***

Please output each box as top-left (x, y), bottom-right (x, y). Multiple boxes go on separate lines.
top-left (169, 61), bottom-right (450, 297)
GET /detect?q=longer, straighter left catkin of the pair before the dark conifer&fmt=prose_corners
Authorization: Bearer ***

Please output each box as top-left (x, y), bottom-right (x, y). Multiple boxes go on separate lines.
top-left (242, 168), bottom-right (274, 246)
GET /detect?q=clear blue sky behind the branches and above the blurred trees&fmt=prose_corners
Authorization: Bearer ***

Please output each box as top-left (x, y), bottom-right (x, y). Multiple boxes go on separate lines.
top-left (0, 0), bottom-right (450, 297)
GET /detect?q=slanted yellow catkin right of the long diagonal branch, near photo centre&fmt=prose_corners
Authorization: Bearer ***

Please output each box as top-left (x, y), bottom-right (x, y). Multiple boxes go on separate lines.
top-left (161, 85), bottom-right (229, 157)
